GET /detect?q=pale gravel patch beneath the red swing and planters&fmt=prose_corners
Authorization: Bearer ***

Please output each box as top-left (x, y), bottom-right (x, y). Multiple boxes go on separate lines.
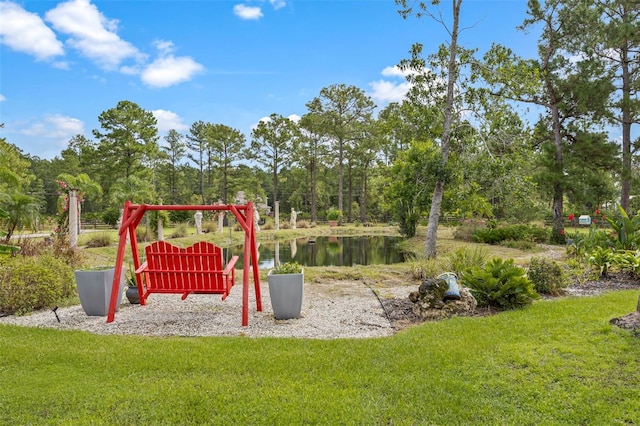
top-left (0, 281), bottom-right (409, 339)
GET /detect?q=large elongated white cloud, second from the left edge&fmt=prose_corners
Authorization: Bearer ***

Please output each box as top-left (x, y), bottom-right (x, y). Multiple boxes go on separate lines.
top-left (45, 0), bottom-right (144, 70)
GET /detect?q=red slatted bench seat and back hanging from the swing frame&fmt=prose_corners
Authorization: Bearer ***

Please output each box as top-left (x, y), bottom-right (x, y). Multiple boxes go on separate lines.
top-left (145, 241), bottom-right (228, 294)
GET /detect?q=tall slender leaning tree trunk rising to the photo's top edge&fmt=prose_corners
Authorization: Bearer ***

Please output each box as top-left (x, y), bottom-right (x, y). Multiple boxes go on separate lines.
top-left (425, 0), bottom-right (462, 259)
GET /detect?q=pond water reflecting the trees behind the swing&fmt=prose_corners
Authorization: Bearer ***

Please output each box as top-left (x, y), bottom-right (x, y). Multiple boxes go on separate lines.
top-left (231, 235), bottom-right (404, 269)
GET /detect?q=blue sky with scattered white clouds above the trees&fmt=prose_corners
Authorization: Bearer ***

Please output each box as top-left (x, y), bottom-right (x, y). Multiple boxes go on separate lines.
top-left (0, 0), bottom-right (537, 159)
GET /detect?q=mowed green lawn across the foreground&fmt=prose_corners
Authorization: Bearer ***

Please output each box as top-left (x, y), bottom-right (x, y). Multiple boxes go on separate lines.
top-left (0, 291), bottom-right (640, 425)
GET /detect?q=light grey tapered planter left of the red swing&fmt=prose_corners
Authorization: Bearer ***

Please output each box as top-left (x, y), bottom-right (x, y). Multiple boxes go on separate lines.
top-left (75, 268), bottom-right (125, 317)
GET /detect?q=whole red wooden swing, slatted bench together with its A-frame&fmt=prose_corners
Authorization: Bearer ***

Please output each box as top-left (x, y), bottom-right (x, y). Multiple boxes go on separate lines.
top-left (107, 201), bottom-right (262, 326)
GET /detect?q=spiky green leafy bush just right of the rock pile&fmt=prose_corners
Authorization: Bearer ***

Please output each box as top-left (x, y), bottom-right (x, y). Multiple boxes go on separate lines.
top-left (461, 258), bottom-right (540, 310)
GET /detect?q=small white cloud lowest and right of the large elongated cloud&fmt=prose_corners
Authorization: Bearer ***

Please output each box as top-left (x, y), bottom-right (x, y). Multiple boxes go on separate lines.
top-left (141, 55), bottom-right (204, 88)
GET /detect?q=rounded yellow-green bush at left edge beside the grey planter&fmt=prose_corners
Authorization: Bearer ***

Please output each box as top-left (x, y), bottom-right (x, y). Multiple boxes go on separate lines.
top-left (0, 254), bottom-right (75, 315)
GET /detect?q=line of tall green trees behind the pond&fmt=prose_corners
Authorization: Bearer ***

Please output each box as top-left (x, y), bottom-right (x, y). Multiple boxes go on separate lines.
top-left (0, 0), bottom-right (640, 256)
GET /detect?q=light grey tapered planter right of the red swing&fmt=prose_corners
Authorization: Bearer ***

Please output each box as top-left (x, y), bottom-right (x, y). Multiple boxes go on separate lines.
top-left (267, 270), bottom-right (304, 319)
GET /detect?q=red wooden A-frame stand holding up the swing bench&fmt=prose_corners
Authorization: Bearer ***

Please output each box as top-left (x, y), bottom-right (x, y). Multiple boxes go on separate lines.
top-left (107, 201), bottom-right (262, 326)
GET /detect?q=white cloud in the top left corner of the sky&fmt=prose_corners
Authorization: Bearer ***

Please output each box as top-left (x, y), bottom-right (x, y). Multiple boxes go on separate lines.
top-left (0, 1), bottom-right (64, 61)
